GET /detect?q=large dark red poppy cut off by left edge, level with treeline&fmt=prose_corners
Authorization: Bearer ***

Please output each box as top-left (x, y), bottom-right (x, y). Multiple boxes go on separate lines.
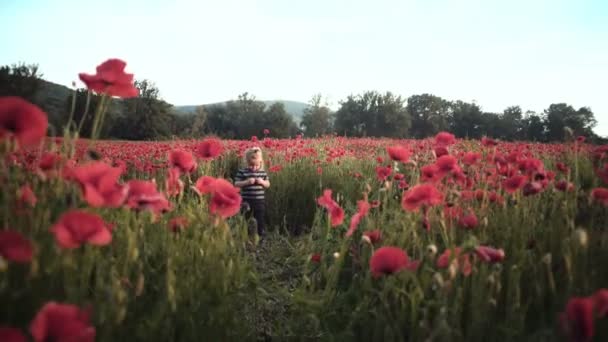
top-left (0, 96), bottom-right (49, 147)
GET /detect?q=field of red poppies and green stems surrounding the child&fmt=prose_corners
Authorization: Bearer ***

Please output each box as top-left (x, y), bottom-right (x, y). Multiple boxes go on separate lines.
top-left (0, 59), bottom-right (608, 341)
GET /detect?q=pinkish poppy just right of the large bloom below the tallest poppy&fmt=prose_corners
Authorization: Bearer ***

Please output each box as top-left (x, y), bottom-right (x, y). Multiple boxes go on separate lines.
top-left (126, 180), bottom-right (171, 214)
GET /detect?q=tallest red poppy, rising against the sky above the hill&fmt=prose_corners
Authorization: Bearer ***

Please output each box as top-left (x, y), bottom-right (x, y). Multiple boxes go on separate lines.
top-left (78, 58), bottom-right (139, 98)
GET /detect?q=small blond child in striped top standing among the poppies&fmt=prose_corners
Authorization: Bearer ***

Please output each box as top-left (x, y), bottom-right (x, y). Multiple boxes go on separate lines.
top-left (234, 147), bottom-right (270, 238)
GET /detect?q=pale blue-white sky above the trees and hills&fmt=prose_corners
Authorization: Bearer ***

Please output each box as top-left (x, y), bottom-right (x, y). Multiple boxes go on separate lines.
top-left (0, 0), bottom-right (608, 136)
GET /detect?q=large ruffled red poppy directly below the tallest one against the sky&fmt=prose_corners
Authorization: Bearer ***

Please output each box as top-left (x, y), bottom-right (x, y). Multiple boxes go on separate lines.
top-left (66, 161), bottom-right (127, 208)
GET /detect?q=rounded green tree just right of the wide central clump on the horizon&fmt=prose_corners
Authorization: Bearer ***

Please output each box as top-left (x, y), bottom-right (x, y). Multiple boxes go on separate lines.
top-left (407, 94), bottom-right (450, 138)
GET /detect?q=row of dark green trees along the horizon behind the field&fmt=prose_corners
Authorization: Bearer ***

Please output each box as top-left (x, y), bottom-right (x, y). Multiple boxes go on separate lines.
top-left (0, 63), bottom-right (601, 142)
